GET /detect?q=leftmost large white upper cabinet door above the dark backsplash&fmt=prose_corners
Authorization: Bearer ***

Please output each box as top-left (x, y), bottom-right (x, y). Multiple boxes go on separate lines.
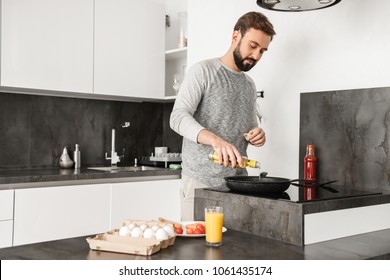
top-left (1, 0), bottom-right (94, 93)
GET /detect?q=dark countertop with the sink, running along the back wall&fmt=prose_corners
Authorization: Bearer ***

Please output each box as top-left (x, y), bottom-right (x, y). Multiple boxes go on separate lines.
top-left (0, 168), bottom-right (181, 190)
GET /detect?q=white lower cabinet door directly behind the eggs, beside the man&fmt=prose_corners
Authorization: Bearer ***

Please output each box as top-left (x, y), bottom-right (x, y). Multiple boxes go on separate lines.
top-left (111, 179), bottom-right (181, 228)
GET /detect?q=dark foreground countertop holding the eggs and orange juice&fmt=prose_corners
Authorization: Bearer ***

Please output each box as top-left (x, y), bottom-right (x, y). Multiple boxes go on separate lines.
top-left (0, 229), bottom-right (390, 260)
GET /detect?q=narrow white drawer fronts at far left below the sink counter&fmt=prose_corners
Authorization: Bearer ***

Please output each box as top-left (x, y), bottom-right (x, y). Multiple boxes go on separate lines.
top-left (0, 190), bottom-right (14, 248)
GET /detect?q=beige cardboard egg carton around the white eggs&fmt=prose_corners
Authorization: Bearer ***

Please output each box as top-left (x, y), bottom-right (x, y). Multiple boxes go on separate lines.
top-left (87, 220), bottom-right (176, 256)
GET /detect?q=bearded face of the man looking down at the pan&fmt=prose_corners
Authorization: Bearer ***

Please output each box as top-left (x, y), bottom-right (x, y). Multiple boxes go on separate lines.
top-left (233, 28), bottom-right (271, 72)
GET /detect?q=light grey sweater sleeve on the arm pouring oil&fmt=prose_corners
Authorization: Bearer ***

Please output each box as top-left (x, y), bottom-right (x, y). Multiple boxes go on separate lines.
top-left (169, 64), bottom-right (206, 142)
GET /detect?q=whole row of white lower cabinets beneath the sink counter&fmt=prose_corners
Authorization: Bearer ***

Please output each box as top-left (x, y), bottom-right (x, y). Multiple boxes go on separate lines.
top-left (9, 179), bottom-right (180, 248)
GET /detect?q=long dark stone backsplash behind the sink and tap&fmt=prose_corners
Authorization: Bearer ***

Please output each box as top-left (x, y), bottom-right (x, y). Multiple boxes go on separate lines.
top-left (0, 93), bottom-right (182, 168)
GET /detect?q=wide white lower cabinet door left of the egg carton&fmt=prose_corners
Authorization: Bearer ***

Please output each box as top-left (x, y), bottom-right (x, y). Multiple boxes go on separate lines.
top-left (14, 184), bottom-right (111, 246)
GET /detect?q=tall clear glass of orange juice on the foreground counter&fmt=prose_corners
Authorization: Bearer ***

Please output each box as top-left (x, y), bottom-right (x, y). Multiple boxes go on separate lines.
top-left (205, 206), bottom-right (223, 247)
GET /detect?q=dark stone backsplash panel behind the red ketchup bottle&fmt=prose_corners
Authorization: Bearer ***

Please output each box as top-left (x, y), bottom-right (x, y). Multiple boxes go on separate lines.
top-left (299, 87), bottom-right (390, 191)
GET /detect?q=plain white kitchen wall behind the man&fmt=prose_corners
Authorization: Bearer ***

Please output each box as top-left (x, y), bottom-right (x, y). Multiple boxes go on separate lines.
top-left (188, 0), bottom-right (390, 178)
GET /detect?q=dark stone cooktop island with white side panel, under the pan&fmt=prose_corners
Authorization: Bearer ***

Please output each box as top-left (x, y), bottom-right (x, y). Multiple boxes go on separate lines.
top-left (194, 186), bottom-right (390, 246)
